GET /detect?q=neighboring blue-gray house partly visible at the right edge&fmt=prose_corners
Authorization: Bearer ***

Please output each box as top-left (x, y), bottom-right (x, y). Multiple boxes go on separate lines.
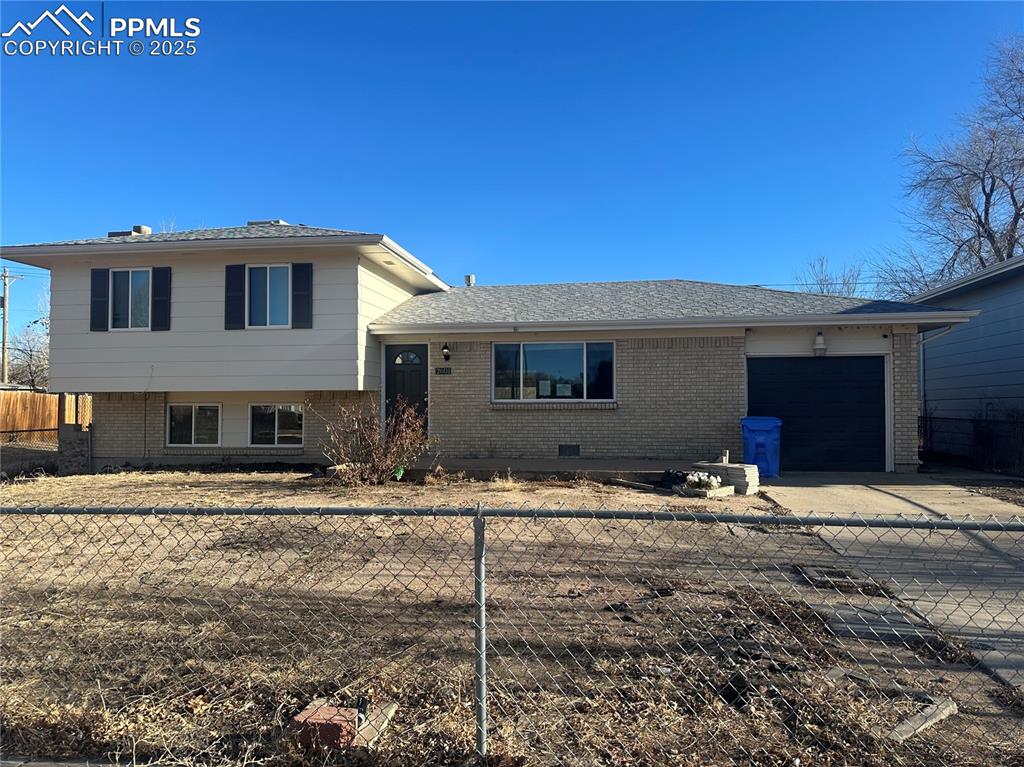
top-left (913, 257), bottom-right (1024, 472)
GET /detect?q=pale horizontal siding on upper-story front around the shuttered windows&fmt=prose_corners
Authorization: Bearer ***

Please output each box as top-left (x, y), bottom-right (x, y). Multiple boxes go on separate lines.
top-left (50, 251), bottom-right (366, 392)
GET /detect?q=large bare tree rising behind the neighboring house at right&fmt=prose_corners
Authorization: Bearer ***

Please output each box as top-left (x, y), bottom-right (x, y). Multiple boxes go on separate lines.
top-left (877, 38), bottom-right (1024, 298)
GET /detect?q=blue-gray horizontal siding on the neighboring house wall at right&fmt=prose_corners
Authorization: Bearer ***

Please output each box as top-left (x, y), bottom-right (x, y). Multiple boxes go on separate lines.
top-left (921, 269), bottom-right (1024, 420)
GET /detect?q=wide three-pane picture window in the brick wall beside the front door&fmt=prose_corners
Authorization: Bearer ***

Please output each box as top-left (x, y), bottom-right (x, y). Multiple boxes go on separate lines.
top-left (493, 341), bottom-right (615, 400)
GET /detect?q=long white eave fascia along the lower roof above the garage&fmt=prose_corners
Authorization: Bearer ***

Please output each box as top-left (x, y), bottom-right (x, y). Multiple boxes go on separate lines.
top-left (370, 309), bottom-right (979, 336)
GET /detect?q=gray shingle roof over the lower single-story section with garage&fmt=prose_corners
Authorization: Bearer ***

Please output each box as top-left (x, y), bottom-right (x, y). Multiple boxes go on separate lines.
top-left (373, 280), bottom-right (943, 326)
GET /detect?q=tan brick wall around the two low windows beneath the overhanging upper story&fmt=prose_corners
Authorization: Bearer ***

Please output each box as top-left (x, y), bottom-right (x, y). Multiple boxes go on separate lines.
top-left (90, 391), bottom-right (378, 470)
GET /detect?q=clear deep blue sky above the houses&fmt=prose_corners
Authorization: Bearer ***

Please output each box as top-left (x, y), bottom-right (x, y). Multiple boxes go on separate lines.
top-left (0, 0), bottom-right (1024, 326)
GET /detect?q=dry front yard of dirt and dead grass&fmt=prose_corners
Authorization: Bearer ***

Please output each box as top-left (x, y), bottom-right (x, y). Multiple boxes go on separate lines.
top-left (0, 473), bottom-right (1024, 767)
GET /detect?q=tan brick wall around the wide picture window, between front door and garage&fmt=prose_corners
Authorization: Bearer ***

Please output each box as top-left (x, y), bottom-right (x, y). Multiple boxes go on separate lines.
top-left (429, 336), bottom-right (746, 461)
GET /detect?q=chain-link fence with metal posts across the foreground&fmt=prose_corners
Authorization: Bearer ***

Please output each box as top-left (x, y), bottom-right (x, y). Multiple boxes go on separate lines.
top-left (0, 505), bottom-right (1024, 765)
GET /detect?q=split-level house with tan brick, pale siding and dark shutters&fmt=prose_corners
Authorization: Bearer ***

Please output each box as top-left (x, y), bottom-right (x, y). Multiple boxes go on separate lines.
top-left (2, 220), bottom-right (973, 471)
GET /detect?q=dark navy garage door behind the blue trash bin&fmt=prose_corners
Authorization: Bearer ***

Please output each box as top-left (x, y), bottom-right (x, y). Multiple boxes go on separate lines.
top-left (746, 356), bottom-right (886, 471)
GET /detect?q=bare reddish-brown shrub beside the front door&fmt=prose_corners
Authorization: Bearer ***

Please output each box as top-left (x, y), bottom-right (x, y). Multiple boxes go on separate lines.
top-left (324, 397), bottom-right (430, 486)
